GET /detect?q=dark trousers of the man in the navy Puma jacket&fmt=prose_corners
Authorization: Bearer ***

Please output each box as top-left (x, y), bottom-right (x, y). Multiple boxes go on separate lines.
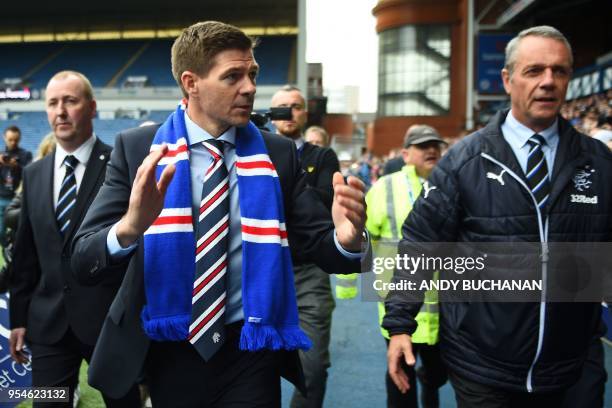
top-left (448, 370), bottom-right (568, 408)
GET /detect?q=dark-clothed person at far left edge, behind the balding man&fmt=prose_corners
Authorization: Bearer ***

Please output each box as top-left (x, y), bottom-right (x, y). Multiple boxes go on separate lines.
top-left (0, 126), bottom-right (32, 246)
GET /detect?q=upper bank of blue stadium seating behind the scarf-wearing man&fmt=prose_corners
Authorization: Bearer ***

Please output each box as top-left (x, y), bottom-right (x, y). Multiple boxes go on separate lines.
top-left (0, 36), bottom-right (296, 88)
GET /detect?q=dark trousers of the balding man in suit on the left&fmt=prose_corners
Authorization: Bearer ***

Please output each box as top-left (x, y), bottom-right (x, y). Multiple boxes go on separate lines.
top-left (30, 329), bottom-right (140, 408)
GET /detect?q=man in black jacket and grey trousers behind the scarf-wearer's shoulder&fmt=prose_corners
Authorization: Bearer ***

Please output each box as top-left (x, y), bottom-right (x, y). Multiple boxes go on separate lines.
top-left (271, 85), bottom-right (340, 408)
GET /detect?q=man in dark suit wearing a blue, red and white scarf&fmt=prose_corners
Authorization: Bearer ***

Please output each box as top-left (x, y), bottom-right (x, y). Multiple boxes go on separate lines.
top-left (72, 21), bottom-right (365, 407)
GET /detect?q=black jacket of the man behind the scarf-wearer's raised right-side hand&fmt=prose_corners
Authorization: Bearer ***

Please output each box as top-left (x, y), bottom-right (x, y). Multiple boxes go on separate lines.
top-left (300, 142), bottom-right (340, 209)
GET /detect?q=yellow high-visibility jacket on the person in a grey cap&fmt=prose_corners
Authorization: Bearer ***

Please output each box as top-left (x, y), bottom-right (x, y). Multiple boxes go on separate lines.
top-left (366, 166), bottom-right (439, 345)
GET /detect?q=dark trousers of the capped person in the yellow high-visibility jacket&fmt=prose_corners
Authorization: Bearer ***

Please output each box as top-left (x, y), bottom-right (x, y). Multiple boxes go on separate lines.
top-left (385, 340), bottom-right (447, 408)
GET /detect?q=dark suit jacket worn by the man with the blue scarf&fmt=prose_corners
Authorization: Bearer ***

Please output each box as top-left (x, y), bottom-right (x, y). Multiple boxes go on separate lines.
top-left (72, 126), bottom-right (359, 398)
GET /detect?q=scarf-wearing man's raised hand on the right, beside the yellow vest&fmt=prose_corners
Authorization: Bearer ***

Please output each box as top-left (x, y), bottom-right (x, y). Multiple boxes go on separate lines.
top-left (332, 172), bottom-right (366, 252)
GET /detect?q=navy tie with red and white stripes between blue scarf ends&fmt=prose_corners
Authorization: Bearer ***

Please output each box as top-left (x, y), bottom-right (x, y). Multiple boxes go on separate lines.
top-left (188, 140), bottom-right (229, 360)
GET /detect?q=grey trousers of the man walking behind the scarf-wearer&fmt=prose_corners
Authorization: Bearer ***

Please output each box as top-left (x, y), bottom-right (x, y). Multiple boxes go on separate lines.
top-left (291, 264), bottom-right (336, 408)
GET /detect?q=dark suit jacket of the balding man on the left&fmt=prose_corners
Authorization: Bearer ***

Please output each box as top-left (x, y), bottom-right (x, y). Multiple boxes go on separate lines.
top-left (10, 140), bottom-right (115, 346)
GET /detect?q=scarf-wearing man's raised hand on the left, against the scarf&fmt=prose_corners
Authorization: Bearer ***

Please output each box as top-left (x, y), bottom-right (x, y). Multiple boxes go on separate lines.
top-left (117, 145), bottom-right (176, 247)
